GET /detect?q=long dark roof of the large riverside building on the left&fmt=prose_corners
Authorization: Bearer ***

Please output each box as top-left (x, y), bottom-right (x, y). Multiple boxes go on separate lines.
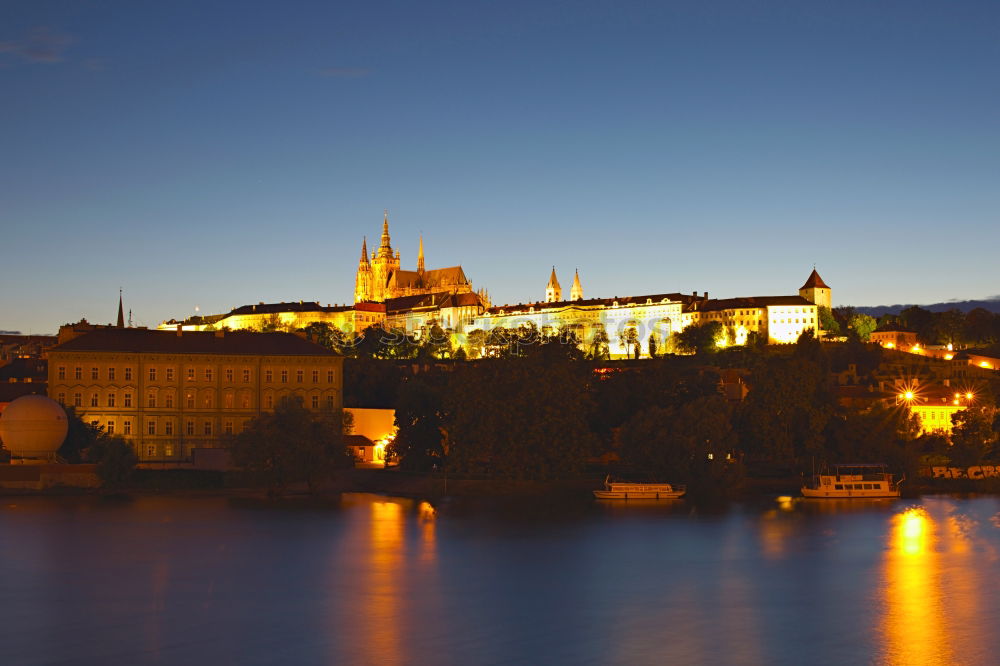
top-left (50, 328), bottom-right (335, 356)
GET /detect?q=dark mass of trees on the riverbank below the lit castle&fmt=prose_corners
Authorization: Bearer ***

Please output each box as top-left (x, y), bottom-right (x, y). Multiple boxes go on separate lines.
top-left (376, 336), bottom-right (998, 491)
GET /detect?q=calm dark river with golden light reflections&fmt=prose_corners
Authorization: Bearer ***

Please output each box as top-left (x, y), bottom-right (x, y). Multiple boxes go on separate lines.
top-left (0, 495), bottom-right (1000, 666)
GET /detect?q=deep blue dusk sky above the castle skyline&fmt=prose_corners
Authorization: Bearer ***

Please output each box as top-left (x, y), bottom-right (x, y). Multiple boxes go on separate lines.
top-left (0, 0), bottom-right (1000, 332)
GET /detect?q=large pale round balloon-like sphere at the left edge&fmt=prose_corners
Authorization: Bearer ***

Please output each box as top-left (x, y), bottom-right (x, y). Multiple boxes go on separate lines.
top-left (0, 395), bottom-right (69, 458)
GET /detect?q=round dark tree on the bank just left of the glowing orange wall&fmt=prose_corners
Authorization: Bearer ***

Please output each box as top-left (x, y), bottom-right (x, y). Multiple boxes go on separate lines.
top-left (229, 396), bottom-right (353, 497)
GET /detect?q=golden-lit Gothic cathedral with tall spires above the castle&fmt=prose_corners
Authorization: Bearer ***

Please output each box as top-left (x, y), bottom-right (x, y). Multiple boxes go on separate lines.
top-left (354, 211), bottom-right (472, 303)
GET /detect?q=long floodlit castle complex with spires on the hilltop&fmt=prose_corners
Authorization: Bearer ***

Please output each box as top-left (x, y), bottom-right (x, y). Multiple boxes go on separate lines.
top-left (160, 213), bottom-right (832, 358)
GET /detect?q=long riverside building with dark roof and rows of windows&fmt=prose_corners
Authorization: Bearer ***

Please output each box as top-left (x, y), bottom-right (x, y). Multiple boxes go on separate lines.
top-left (48, 327), bottom-right (344, 462)
